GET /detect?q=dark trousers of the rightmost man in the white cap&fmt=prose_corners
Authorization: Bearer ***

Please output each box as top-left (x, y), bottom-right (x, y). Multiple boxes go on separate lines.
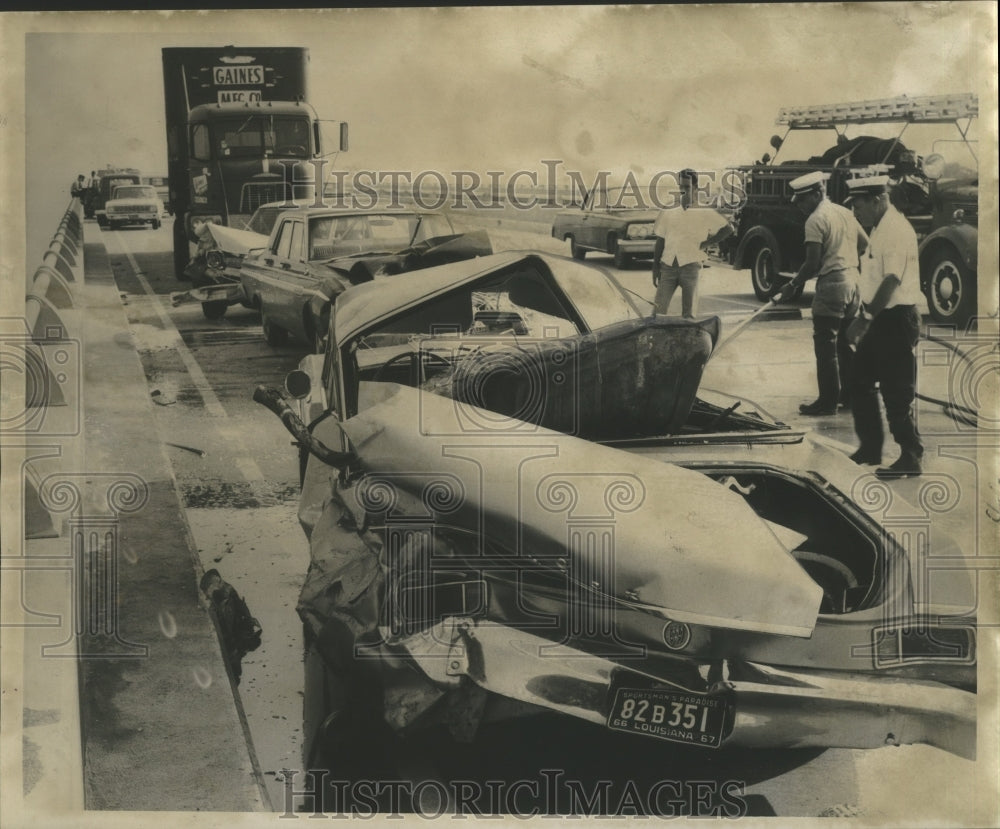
top-left (851, 305), bottom-right (924, 458)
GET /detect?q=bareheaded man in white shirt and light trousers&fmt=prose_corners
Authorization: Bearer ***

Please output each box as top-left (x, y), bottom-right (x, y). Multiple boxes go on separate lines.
top-left (653, 169), bottom-right (733, 319)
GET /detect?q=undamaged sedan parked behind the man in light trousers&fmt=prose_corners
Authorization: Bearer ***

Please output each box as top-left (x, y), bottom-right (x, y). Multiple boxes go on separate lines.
top-left (552, 188), bottom-right (659, 268)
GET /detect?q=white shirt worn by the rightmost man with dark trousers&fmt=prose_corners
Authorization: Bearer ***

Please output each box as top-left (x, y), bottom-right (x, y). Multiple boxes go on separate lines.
top-left (859, 204), bottom-right (921, 308)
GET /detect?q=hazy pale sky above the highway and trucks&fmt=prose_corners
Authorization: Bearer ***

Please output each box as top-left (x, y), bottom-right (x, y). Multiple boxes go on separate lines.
top-left (0, 3), bottom-right (996, 258)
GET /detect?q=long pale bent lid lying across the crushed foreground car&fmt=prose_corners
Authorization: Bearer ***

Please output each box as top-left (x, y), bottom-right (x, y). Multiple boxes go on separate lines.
top-left (328, 384), bottom-right (821, 636)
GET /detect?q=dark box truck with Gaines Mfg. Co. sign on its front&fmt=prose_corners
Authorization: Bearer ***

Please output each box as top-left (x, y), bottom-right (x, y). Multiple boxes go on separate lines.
top-left (163, 46), bottom-right (346, 281)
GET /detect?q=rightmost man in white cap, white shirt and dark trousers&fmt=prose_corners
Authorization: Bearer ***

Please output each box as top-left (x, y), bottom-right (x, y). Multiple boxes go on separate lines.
top-left (848, 167), bottom-right (924, 478)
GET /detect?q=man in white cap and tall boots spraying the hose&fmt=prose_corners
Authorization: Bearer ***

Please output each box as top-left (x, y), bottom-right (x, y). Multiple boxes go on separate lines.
top-left (778, 171), bottom-right (868, 416)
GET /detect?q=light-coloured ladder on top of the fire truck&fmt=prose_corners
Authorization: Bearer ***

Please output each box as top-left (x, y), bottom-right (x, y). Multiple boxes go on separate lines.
top-left (775, 93), bottom-right (979, 129)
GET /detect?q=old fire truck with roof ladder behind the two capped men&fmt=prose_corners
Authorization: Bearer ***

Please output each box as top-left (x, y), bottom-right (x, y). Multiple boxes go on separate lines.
top-left (725, 94), bottom-right (979, 328)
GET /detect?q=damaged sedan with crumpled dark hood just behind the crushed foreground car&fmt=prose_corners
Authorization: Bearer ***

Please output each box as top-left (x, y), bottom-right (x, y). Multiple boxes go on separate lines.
top-left (240, 207), bottom-right (493, 349)
